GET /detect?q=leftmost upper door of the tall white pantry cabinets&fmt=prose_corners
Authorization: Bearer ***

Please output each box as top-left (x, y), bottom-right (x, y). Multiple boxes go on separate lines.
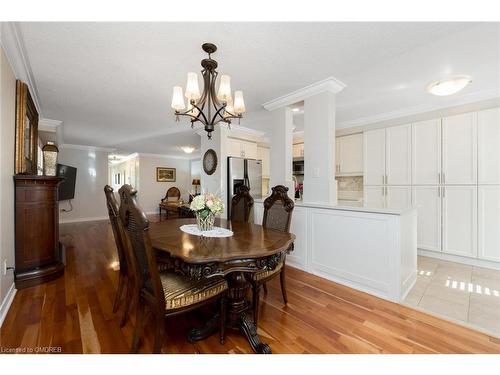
top-left (363, 129), bottom-right (385, 185)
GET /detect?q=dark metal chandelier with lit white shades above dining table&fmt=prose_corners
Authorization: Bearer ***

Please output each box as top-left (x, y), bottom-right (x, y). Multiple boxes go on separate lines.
top-left (172, 43), bottom-right (245, 139)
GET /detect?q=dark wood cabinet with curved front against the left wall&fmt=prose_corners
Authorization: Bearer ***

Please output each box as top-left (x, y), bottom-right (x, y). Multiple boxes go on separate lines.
top-left (14, 175), bottom-right (64, 289)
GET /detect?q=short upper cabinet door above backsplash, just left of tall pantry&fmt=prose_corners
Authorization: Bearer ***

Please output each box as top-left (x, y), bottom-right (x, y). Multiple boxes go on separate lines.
top-left (337, 134), bottom-right (363, 175)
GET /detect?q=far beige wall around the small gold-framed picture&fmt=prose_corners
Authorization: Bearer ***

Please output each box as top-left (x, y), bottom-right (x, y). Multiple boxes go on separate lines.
top-left (137, 155), bottom-right (192, 213)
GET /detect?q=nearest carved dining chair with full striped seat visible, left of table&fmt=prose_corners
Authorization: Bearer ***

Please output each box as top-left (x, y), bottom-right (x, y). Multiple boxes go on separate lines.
top-left (119, 185), bottom-right (228, 353)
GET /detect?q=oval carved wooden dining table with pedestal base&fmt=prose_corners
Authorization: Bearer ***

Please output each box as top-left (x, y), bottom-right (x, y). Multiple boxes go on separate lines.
top-left (149, 219), bottom-right (295, 354)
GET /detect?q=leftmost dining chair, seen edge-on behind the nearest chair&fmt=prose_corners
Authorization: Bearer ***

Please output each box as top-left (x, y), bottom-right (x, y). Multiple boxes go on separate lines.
top-left (104, 185), bottom-right (133, 327)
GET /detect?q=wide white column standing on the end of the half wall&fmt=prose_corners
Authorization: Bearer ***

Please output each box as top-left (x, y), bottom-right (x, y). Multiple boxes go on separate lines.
top-left (302, 91), bottom-right (337, 204)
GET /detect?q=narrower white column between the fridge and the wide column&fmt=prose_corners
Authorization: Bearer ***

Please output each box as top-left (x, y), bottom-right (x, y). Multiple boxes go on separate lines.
top-left (269, 107), bottom-right (295, 199)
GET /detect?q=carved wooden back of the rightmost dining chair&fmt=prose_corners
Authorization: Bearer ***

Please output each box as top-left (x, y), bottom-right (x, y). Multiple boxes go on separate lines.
top-left (262, 185), bottom-right (295, 232)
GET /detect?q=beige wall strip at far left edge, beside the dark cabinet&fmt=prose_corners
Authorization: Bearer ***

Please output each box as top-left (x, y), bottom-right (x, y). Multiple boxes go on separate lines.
top-left (0, 49), bottom-right (16, 325)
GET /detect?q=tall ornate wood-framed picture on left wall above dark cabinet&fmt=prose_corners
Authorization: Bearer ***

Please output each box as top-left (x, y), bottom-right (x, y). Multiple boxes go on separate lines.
top-left (15, 80), bottom-right (38, 174)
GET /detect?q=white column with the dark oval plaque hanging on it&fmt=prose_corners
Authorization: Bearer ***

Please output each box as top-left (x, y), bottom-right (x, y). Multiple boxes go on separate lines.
top-left (198, 125), bottom-right (228, 219)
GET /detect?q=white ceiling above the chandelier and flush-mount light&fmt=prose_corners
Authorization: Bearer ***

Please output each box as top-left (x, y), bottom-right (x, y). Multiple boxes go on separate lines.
top-left (16, 22), bottom-right (500, 154)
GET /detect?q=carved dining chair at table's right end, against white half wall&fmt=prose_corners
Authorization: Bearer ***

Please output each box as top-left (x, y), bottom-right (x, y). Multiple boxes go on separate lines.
top-left (251, 185), bottom-right (294, 324)
